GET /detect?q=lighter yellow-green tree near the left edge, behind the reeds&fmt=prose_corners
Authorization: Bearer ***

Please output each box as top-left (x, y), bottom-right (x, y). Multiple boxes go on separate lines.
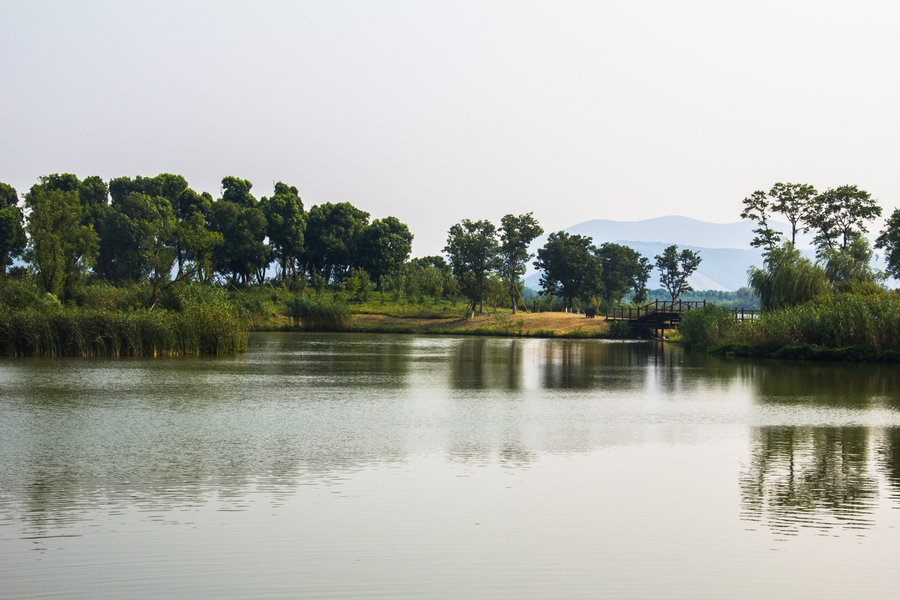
top-left (25, 180), bottom-right (99, 301)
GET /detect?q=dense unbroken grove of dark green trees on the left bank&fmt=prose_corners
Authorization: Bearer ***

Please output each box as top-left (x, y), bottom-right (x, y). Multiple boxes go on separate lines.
top-left (0, 173), bottom-right (413, 304)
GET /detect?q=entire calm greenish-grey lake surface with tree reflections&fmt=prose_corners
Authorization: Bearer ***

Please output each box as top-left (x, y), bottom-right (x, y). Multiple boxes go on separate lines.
top-left (0, 334), bottom-right (900, 599)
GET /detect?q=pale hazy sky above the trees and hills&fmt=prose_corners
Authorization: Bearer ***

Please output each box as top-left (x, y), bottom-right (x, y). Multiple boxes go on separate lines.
top-left (0, 0), bottom-right (900, 255)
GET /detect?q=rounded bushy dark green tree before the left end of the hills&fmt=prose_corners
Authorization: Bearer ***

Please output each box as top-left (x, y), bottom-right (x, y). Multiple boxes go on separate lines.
top-left (534, 231), bottom-right (603, 312)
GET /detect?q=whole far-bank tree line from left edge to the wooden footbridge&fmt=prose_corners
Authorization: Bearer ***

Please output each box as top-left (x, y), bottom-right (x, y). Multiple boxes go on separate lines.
top-left (0, 173), bottom-right (700, 314)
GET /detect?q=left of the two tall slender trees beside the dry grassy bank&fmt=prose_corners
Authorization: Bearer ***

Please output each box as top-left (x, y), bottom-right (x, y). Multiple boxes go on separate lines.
top-left (444, 219), bottom-right (499, 317)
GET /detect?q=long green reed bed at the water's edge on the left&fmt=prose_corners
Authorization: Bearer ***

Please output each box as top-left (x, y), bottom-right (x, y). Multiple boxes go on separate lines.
top-left (0, 305), bottom-right (249, 357)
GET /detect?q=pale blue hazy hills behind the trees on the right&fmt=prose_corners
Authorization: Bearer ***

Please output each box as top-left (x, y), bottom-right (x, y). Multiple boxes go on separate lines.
top-left (525, 216), bottom-right (814, 291)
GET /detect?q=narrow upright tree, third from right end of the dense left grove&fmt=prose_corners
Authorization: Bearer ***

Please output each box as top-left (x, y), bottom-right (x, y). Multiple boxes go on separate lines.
top-left (259, 181), bottom-right (306, 282)
